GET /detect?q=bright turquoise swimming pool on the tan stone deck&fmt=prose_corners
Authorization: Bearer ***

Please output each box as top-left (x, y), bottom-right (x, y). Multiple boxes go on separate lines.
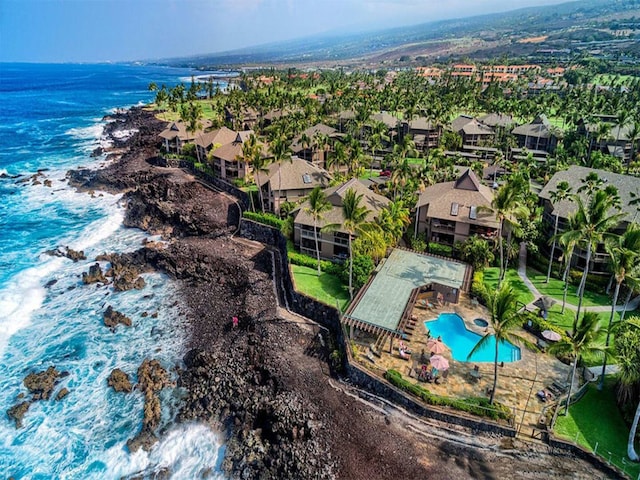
top-left (425, 313), bottom-right (520, 363)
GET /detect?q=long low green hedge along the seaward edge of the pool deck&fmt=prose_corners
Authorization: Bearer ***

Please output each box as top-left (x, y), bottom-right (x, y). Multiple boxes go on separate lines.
top-left (384, 370), bottom-right (513, 421)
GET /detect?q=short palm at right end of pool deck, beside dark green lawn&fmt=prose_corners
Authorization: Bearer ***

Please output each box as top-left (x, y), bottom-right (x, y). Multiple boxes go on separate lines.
top-left (549, 312), bottom-right (605, 415)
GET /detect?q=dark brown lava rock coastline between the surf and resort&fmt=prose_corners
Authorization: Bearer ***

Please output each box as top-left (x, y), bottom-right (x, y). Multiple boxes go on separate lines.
top-left (56, 108), bottom-right (616, 480)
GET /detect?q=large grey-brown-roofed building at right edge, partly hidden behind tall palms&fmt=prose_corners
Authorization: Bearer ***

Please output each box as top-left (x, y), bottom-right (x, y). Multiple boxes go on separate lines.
top-left (539, 165), bottom-right (640, 274)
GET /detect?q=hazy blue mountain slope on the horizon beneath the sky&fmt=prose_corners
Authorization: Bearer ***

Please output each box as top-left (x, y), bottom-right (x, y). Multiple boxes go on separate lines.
top-left (159, 0), bottom-right (640, 66)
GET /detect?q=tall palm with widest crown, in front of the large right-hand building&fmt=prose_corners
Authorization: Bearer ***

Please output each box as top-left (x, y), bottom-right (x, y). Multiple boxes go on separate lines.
top-left (561, 186), bottom-right (625, 331)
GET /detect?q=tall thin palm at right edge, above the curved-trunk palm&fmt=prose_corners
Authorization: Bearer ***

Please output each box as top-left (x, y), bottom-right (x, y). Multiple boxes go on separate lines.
top-left (598, 223), bottom-right (640, 390)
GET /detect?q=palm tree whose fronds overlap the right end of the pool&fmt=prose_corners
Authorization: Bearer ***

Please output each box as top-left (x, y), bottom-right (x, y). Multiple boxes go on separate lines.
top-left (467, 282), bottom-right (535, 404)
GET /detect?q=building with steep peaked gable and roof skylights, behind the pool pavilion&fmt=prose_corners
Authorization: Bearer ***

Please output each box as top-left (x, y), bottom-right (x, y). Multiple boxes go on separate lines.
top-left (416, 168), bottom-right (499, 246)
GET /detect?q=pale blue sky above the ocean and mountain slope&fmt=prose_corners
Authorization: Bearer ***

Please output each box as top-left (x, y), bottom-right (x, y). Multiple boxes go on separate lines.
top-left (0, 0), bottom-right (564, 63)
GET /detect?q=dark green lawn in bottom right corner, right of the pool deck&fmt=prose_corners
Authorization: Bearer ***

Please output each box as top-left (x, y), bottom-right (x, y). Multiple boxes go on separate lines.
top-left (555, 378), bottom-right (640, 479)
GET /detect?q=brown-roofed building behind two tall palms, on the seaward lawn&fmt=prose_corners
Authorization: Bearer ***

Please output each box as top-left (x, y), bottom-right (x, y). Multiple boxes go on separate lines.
top-left (293, 178), bottom-right (389, 260)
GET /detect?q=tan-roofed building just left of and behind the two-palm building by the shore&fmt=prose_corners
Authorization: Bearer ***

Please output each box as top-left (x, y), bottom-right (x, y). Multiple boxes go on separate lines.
top-left (259, 156), bottom-right (331, 213)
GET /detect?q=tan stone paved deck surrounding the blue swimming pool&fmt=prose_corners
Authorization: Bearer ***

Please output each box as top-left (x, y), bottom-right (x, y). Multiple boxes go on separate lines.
top-left (355, 295), bottom-right (570, 433)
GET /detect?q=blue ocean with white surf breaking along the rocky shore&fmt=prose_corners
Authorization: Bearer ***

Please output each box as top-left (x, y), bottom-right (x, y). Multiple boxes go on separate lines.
top-left (0, 64), bottom-right (229, 480)
